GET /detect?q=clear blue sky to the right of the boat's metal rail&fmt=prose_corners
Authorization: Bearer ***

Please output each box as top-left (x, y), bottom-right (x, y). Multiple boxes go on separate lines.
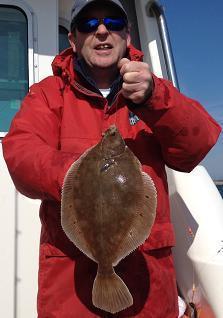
top-left (160, 0), bottom-right (223, 179)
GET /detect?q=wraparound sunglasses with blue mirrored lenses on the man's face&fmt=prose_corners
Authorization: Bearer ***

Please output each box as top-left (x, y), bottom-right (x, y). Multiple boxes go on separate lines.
top-left (74, 17), bottom-right (127, 33)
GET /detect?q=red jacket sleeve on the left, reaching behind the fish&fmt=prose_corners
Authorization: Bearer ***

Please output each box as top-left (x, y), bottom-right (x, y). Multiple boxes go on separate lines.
top-left (2, 77), bottom-right (76, 200)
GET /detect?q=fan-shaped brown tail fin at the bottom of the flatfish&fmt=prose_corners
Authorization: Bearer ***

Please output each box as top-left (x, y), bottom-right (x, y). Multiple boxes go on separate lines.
top-left (92, 272), bottom-right (133, 314)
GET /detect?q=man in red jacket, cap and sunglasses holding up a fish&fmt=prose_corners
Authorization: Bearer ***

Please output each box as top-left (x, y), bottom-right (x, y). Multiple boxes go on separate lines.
top-left (3, 0), bottom-right (220, 318)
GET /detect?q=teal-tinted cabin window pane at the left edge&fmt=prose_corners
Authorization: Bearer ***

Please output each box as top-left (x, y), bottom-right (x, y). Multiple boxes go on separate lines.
top-left (0, 5), bottom-right (28, 132)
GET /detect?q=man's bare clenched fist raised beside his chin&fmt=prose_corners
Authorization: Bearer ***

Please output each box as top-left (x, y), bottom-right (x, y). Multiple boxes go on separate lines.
top-left (118, 58), bottom-right (153, 104)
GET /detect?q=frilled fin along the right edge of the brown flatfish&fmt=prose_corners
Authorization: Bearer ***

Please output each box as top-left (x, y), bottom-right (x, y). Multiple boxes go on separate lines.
top-left (112, 172), bottom-right (157, 266)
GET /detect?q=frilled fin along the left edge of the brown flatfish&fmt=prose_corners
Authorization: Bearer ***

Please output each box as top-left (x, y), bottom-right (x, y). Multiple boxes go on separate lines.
top-left (61, 146), bottom-right (96, 262)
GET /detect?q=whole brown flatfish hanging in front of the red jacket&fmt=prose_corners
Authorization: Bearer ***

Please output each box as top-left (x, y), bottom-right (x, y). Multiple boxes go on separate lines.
top-left (61, 125), bottom-right (157, 313)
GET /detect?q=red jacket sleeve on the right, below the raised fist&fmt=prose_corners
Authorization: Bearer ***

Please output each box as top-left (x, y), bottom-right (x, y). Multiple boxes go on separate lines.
top-left (130, 75), bottom-right (221, 172)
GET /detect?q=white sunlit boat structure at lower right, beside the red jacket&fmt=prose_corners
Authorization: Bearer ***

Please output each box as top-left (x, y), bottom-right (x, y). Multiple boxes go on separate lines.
top-left (167, 166), bottom-right (223, 318)
